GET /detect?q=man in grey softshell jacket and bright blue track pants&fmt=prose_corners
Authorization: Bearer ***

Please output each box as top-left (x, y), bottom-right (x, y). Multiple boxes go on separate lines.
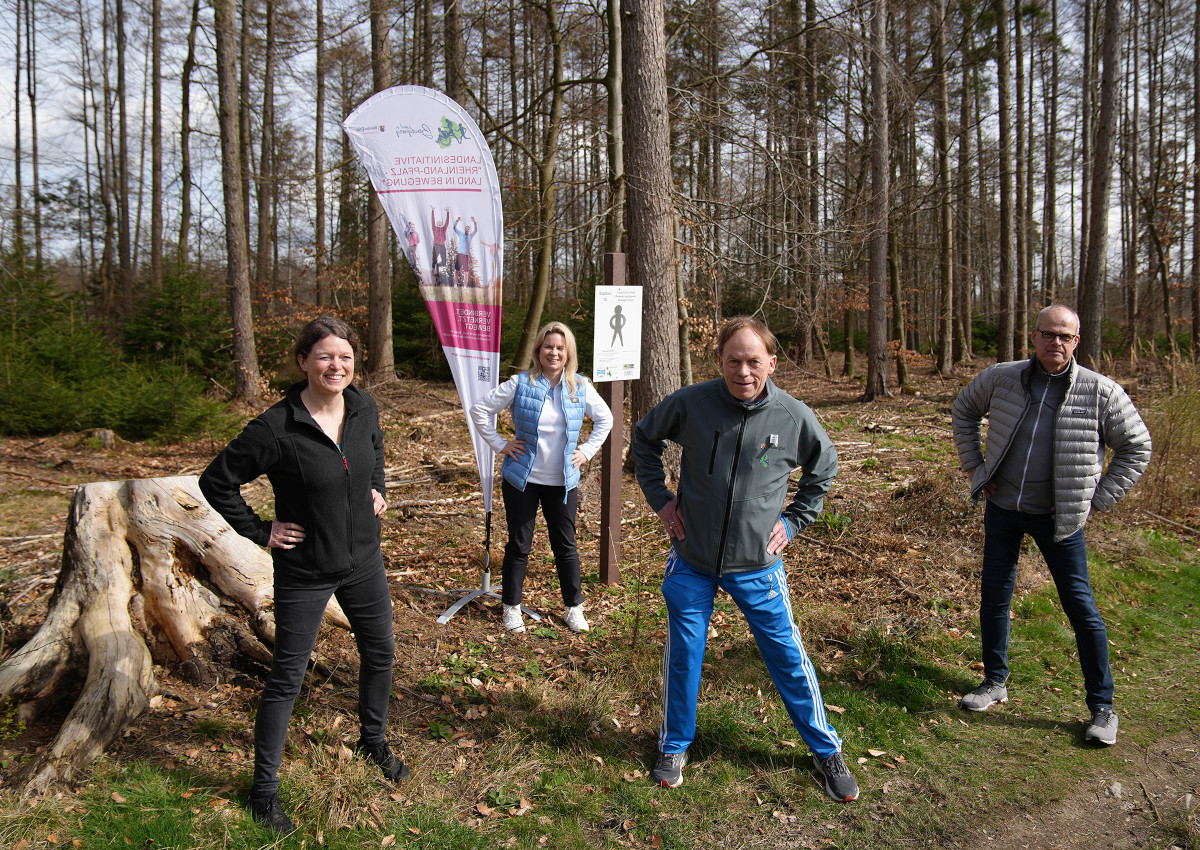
top-left (632, 316), bottom-right (858, 802)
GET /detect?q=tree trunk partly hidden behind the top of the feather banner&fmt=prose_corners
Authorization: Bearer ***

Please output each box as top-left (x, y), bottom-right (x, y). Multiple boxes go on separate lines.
top-left (366, 0), bottom-right (396, 382)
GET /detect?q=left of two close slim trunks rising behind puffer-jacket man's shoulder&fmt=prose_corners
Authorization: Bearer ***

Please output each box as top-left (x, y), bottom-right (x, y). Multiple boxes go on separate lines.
top-left (994, 0), bottom-right (1015, 360)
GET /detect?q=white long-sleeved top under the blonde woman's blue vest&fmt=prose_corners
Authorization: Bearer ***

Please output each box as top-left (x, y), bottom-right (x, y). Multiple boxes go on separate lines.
top-left (470, 373), bottom-right (612, 487)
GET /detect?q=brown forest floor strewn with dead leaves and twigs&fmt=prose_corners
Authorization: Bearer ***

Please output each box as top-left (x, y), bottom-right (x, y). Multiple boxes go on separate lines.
top-left (0, 350), bottom-right (1200, 850)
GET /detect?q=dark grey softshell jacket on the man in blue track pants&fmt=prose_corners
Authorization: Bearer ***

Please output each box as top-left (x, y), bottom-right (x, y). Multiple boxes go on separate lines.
top-left (632, 378), bottom-right (838, 575)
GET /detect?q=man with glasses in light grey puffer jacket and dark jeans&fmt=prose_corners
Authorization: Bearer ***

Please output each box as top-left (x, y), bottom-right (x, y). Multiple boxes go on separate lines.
top-left (953, 305), bottom-right (1150, 746)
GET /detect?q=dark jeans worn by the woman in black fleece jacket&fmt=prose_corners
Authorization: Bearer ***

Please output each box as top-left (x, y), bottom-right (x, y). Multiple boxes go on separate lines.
top-left (252, 558), bottom-right (396, 796)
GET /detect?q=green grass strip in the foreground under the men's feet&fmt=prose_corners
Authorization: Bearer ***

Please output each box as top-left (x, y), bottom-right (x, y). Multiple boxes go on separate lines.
top-left (0, 533), bottom-right (1200, 849)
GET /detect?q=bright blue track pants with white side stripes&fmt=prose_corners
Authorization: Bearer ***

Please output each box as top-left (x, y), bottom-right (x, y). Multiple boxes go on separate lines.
top-left (659, 549), bottom-right (841, 759)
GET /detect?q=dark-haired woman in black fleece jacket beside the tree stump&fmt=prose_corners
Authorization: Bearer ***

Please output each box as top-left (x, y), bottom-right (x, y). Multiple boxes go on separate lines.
top-left (200, 316), bottom-right (408, 834)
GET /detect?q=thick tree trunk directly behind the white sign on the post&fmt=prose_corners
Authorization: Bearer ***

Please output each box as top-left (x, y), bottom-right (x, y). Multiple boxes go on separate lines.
top-left (620, 0), bottom-right (679, 423)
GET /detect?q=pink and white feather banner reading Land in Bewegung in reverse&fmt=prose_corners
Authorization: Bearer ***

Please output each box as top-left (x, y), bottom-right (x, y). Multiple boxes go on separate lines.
top-left (342, 85), bottom-right (504, 511)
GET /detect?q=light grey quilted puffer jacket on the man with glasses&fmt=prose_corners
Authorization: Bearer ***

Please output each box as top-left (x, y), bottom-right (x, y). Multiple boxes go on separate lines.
top-left (952, 358), bottom-right (1151, 540)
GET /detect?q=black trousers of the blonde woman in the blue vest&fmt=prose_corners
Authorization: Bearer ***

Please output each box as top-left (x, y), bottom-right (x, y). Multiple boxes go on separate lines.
top-left (500, 481), bottom-right (583, 607)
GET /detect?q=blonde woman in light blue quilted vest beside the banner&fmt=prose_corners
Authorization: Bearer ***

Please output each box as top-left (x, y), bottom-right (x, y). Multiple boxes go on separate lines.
top-left (470, 322), bottom-right (612, 633)
